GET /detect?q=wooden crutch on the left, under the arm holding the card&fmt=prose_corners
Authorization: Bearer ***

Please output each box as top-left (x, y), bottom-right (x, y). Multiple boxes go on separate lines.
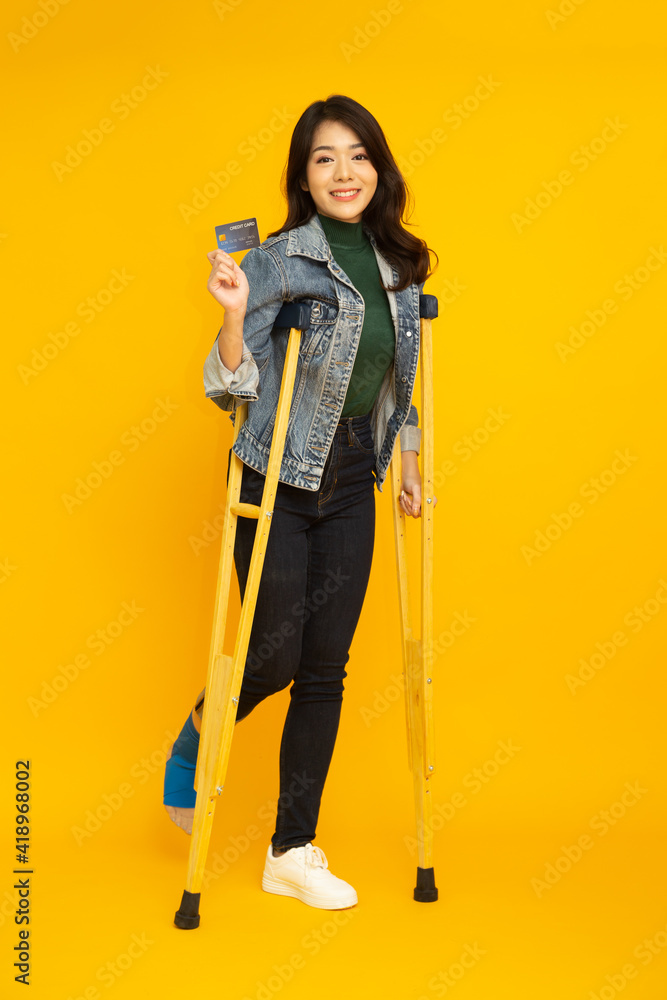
top-left (174, 302), bottom-right (310, 930)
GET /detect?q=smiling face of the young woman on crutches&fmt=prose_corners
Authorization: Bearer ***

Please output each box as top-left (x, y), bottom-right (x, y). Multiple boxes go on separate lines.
top-left (301, 122), bottom-right (378, 222)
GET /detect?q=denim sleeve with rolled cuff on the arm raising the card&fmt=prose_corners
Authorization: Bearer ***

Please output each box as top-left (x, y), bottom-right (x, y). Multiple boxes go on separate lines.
top-left (204, 247), bottom-right (287, 410)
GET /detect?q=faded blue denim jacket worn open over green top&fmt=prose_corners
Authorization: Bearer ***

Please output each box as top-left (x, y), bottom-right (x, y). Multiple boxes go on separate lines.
top-left (204, 214), bottom-right (424, 492)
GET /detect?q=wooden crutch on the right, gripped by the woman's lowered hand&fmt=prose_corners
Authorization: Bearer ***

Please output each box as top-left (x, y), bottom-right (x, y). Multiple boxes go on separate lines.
top-left (390, 295), bottom-right (438, 903)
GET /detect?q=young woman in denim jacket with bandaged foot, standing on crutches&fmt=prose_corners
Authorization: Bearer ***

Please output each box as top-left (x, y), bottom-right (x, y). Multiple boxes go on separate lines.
top-left (164, 94), bottom-right (437, 909)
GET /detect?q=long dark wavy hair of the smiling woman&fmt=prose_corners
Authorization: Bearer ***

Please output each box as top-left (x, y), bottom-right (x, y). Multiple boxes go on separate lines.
top-left (267, 94), bottom-right (438, 292)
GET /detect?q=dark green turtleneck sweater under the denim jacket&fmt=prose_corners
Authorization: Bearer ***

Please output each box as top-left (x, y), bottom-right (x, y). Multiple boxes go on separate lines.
top-left (317, 212), bottom-right (396, 419)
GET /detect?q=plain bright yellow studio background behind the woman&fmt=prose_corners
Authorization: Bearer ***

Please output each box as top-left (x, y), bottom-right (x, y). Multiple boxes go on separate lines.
top-left (0, 0), bottom-right (667, 1000)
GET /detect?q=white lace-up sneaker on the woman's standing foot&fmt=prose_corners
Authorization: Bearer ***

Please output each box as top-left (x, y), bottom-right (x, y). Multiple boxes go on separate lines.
top-left (262, 842), bottom-right (358, 910)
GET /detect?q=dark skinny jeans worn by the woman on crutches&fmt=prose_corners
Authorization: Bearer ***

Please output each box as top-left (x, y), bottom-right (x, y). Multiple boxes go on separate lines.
top-left (228, 414), bottom-right (375, 849)
